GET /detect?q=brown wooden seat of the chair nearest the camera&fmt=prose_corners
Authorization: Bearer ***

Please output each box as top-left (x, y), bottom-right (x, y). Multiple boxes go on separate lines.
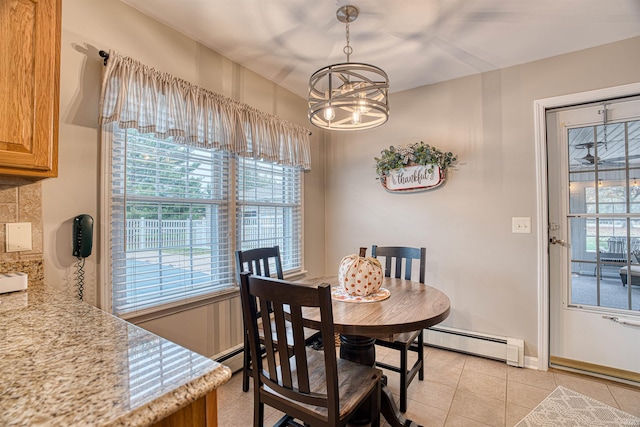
top-left (261, 348), bottom-right (382, 419)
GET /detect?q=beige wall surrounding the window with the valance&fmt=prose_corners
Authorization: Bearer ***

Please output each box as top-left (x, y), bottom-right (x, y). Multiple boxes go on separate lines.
top-left (37, 0), bottom-right (325, 355)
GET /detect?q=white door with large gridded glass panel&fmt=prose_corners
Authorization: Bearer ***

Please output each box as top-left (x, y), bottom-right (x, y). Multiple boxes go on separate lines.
top-left (547, 99), bottom-right (640, 382)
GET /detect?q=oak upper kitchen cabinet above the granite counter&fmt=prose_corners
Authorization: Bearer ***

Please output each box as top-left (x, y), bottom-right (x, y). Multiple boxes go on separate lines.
top-left (0, 0), bottom-right (62, 179)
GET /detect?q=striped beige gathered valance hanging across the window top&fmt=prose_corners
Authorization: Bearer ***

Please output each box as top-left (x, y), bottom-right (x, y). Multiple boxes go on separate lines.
top-left (100, 51), bottom-right (311, 170)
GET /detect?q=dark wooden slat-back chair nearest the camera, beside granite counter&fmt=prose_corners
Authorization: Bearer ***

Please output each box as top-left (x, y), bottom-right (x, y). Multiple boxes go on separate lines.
top-left (240, 272), bottom-right (382, 427)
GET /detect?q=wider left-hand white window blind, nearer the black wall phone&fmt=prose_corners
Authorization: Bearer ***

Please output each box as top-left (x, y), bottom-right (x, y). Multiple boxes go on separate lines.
top-left (111, 125), bottom-right (234, 315)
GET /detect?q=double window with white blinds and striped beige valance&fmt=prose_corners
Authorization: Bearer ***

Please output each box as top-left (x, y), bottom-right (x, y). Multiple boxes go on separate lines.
top-left (99, 51), bottom-right (311, 317)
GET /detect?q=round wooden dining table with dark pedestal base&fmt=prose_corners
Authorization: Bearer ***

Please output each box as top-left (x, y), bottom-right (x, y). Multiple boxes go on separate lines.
top-left (297, 276), bottom-right (451, 427)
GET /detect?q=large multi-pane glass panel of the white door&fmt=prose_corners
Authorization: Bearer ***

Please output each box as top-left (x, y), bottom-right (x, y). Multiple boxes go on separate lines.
top-left (567, 121), bottom-right (640, 310)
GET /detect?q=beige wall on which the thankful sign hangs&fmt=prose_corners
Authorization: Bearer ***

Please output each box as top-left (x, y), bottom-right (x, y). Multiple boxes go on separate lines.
top-left (326, 38), bottom-right (640, 364)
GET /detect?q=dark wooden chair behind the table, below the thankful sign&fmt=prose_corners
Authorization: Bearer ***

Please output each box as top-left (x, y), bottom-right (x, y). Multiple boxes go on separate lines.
top-left (371, 245), bottom-right (427, 412)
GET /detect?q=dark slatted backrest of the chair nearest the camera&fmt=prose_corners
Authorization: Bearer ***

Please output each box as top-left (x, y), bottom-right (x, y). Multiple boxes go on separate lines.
top-left (240, 272), bottom-right (339, 414)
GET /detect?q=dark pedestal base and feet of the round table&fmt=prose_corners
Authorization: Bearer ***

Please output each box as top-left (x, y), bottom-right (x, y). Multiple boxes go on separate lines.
top-left (340, 335), bottom-right (421, 427)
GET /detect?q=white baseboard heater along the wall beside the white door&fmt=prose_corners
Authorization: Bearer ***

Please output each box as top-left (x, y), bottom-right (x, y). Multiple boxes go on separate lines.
top-left (424, 326), bottom-right (524, 368)
